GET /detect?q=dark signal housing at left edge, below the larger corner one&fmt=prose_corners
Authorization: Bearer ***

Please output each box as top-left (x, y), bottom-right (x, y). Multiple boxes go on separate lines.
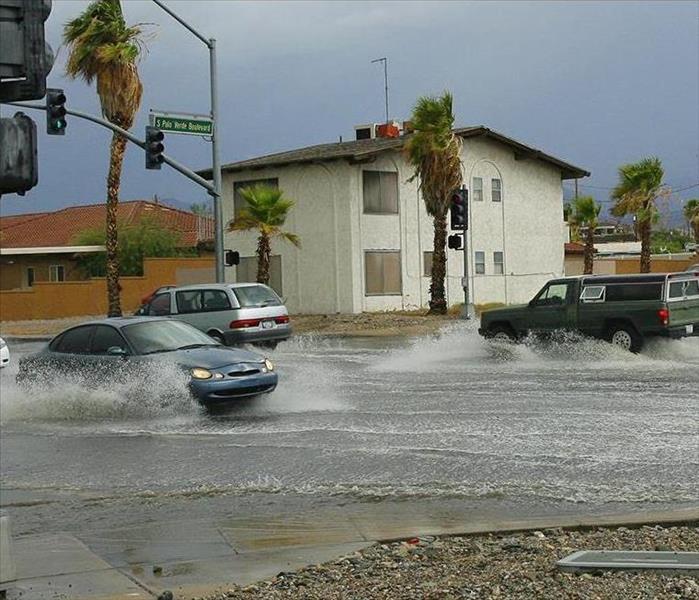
top-left (0, 112), bottom-right (39, 196)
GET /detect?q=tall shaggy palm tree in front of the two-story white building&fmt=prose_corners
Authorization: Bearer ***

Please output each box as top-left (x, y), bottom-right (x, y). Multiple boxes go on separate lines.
top-left (404, 92), bottom-right (462, 314)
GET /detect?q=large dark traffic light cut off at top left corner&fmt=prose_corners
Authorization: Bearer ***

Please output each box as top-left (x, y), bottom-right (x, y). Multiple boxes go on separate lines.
top-left (0, 0), bottom-right (53, 102)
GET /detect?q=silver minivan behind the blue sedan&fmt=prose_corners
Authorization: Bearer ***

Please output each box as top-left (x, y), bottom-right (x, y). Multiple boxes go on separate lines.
top-left (137, 283), bottom-right (291, 348)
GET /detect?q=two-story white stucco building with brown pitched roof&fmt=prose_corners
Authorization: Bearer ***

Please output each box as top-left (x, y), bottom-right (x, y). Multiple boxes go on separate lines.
top-left (202, 126), bottom-right (589, 313)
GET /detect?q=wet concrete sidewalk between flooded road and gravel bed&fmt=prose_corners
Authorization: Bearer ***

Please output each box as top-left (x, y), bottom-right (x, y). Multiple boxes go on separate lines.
top-left (8, 504), bottom-right (699, 600)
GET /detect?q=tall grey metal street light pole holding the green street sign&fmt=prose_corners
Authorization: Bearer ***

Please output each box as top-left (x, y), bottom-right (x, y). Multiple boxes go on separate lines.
top-left (153, 0), bottom-right (225, 283)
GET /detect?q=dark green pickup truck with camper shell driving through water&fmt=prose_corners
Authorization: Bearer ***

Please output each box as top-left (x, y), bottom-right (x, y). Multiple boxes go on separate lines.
top-left (478, 271), bottom-right (699, 352)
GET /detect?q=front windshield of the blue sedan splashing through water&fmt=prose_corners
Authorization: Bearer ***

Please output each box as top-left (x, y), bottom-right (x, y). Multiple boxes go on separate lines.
top-left (122, 321), bottom-right (218, 354)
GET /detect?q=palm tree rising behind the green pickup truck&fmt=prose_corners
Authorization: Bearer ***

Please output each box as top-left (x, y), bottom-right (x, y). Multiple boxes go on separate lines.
top-left (611, 156), bottom-right (665, 273)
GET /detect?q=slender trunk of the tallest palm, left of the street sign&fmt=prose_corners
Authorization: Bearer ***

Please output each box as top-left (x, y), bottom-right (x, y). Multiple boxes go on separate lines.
top-left (105, 133), bottom-right (126, 317)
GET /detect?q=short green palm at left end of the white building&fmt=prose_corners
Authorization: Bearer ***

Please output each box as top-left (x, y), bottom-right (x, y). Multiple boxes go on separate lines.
top-left (228, 185), bottom-right (301, 285)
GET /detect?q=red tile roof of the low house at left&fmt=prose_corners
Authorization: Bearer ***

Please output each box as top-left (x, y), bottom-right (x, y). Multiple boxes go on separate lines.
top-left (0, 200), bottom-right (214, 248)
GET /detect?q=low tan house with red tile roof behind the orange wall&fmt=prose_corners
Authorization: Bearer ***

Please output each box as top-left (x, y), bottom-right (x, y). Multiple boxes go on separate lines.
top-left (0, 200), bottom-right (214, 290)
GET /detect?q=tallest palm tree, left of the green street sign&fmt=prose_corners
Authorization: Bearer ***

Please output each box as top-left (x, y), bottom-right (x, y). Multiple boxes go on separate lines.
top-left (63, 0), bottom-right (143, 317)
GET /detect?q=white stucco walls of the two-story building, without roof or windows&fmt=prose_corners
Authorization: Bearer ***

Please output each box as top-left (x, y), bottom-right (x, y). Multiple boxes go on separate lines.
top-left (224, 138), bottom-right (566, 313)
